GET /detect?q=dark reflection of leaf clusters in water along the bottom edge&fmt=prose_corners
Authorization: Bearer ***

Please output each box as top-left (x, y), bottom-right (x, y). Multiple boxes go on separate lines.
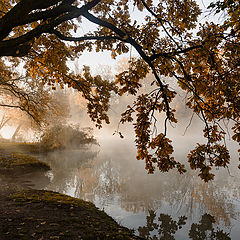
top-left (138, 210), bottom-right (231, 240)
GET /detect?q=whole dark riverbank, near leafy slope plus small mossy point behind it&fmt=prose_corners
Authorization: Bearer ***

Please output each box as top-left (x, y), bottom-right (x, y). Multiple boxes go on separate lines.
top-left (0, 143), bottom-right (141, 240)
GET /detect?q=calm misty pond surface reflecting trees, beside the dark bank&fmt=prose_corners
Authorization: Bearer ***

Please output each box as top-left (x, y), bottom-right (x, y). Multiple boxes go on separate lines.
top-left (36, 137), bottom-right (240, 240)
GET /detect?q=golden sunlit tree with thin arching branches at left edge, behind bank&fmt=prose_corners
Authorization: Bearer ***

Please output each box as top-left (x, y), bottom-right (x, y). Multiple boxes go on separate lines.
top-left (0, 59), bottom-right (67, 125)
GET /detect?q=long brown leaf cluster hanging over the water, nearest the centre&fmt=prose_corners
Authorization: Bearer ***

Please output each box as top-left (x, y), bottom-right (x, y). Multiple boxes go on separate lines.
top-left (121, 90), bottom-right (186, 173)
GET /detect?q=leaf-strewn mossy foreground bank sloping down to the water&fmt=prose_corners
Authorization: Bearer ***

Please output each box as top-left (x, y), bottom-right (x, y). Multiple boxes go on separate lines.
top-left (7, 190), bottom-right (142, 240)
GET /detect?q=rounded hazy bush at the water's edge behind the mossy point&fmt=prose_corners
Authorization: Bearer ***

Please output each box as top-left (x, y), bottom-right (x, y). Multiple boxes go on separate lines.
top-left (40, 125), bottom-right (97, 150)
